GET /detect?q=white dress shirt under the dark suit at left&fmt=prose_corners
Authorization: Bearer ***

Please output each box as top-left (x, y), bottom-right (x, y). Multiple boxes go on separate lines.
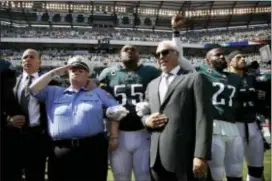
top-left (17, 72), bottom-right (41, 126)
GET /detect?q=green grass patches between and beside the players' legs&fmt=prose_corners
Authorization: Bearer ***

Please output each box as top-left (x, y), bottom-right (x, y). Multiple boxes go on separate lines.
top-left (108, 150), bottom-right (271, 181)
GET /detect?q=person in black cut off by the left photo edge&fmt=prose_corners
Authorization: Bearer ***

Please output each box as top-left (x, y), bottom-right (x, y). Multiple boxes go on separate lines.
top-left (0, 60), bottom-right (25, 181)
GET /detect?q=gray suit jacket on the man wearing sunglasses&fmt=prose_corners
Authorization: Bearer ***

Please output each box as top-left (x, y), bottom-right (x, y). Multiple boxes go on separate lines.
top-left (146, 69), bottom-right (213, 174)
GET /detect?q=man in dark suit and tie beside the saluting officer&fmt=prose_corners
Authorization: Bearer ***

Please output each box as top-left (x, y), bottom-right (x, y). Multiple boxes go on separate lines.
top-left (12, 49), bottom-right (56, 181)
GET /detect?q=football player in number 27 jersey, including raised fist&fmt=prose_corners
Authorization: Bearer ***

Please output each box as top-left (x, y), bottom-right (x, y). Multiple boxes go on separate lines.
top-left (172, 15), bottom-right (243, 181)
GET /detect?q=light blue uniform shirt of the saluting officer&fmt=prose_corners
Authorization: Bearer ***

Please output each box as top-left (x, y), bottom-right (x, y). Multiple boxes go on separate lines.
top-left (34, 86), bottom-right (118, 140)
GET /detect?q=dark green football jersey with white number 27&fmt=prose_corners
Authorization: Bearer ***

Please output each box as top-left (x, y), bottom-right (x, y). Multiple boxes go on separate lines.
top-left (196, 64), bottom-right (241, 122)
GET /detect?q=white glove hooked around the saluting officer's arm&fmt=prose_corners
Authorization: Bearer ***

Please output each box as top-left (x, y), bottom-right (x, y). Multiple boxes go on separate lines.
top-left (106, 105), bottom-right (129, 121)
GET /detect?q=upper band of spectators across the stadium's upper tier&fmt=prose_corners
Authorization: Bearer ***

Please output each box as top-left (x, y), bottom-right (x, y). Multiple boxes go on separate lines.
top-left (1, 26), bottom-right (271, 43)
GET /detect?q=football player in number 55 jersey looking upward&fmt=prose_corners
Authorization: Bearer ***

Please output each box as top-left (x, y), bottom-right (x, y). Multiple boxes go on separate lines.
top-left (99, 45), bottom-right (161, 181)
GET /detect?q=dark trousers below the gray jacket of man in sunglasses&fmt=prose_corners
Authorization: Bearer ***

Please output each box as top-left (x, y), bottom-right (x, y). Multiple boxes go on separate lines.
top-left (150, 155), bottom-right (187, 181)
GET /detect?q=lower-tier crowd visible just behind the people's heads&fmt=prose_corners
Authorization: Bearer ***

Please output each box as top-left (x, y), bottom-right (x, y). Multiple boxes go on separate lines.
top-left (2, 49), bottom-right (266, 66)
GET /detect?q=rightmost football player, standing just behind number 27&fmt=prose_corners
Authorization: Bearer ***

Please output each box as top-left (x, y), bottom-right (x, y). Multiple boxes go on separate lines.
top-left (227, 51), bottom-right (264, 181)
